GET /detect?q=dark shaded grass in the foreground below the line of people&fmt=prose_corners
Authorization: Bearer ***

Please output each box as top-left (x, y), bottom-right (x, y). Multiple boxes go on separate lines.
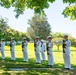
top-left (0, 58), bottom-right (76, 75)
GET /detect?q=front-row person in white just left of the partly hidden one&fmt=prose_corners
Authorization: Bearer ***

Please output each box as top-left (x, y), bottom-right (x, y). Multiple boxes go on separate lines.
top-left (34, 36), bottom-right (41, 64)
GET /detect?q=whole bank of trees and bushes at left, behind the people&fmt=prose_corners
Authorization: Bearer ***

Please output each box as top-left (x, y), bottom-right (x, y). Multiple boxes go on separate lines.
top-left (0, 17), bottom-right (29, 41)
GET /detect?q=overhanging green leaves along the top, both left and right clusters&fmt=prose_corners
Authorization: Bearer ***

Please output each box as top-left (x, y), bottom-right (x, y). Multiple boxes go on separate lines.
top-left (0, 0), bottom-right (76, 20)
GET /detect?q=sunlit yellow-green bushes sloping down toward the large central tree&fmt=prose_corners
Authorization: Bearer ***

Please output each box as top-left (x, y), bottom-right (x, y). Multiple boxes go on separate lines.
top-left (4, 27), bottom-right (29, 41)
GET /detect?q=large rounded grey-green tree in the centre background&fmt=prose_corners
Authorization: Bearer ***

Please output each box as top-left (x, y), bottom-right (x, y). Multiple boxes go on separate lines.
top-left (27, 14), bottom-right (51, 39)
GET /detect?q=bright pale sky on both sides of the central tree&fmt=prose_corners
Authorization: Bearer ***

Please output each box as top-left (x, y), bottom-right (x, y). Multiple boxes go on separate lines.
top-left (0, 0), bottom-right (76, 38)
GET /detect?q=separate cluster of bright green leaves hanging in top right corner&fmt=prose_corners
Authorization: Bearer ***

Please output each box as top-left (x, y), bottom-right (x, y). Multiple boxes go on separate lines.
top-left (62, 0), bottom-right (76, 20)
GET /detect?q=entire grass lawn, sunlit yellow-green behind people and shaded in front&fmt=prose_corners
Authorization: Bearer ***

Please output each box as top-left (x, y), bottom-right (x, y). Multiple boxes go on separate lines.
top-left (0, 43), bottom-right (76, 75)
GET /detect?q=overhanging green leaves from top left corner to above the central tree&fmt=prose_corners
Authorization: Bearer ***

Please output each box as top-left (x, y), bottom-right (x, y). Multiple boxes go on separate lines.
top-left (0, 0), bottom-right (55, 18)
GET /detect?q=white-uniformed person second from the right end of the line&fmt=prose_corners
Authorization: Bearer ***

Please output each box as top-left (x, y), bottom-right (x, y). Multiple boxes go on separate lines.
top-left (47, 36), bottom-right (54, 67)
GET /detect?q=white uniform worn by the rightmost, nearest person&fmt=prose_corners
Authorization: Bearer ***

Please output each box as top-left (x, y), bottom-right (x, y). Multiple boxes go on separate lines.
top-left (63, 40), bottom-right (71, 69)
